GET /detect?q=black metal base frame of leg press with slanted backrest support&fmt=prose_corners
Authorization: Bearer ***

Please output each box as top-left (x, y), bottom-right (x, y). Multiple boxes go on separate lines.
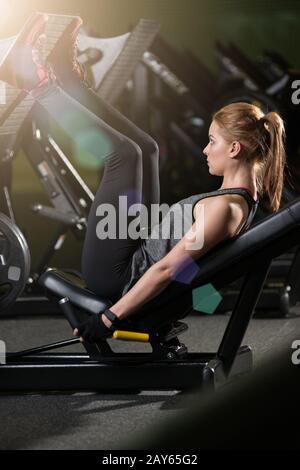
top-left (0, 260), bottom-right (270, 391)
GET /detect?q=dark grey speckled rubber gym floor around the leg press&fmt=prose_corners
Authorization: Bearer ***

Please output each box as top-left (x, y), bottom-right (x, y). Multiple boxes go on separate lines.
top-left (0, 307), bottom-right (300, 450)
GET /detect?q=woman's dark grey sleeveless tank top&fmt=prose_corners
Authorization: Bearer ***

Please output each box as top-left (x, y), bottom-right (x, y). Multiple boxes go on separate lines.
top-left (122, 188), bottom-right (259, 295)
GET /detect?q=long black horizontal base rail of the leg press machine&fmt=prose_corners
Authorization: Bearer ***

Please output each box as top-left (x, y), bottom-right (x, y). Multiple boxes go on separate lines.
top-left (0, 347), bottom-right (252, 391)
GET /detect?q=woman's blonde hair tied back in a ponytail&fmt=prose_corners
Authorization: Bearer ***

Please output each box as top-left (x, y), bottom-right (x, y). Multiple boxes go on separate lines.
top-left (213, 103), bottom-right (286, 212)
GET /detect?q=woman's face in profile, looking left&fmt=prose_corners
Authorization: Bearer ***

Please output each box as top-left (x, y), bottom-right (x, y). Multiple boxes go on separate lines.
top-left (203, 121), bottom-right (232, 176)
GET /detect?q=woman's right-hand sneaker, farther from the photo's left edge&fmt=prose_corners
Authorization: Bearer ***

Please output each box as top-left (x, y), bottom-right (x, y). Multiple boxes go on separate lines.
top-left (47, 16), bottom-right (86, 81)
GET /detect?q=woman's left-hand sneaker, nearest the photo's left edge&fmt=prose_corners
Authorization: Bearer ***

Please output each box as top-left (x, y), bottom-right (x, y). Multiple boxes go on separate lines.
top-left (0, 13), bottom-right (49, 92)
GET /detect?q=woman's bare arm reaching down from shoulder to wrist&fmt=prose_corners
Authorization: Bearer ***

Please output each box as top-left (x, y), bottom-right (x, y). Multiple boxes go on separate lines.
top-left (102, 198), bottom-right (233, 327)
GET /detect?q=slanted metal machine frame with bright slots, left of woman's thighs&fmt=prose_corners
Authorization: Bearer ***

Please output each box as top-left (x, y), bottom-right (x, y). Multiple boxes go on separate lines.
top-left (1, 114), bottom-right (94, 316)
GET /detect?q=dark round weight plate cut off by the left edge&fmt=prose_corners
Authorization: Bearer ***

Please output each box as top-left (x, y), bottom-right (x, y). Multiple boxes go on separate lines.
top-left (0, 212), bottom-right (30, 314)
